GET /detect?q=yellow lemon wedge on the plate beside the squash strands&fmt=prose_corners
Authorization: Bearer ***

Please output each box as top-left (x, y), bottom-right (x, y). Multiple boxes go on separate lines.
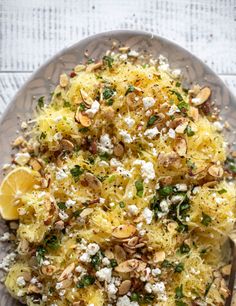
top-left (0, 167), bottom-right (40, 220)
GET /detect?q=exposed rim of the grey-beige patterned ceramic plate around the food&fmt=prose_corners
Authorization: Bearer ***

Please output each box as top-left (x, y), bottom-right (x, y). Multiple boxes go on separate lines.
top-left (0, 30), bottom-right (236, 306)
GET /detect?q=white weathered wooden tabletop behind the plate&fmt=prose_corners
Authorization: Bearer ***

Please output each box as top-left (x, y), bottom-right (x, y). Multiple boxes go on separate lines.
top-left (0, 0), bottom-right (236, 113)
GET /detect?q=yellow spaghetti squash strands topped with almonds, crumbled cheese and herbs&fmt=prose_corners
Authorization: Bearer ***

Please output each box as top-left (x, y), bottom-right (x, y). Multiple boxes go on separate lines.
top-left (2, 51), bottom-right (235, 306)
